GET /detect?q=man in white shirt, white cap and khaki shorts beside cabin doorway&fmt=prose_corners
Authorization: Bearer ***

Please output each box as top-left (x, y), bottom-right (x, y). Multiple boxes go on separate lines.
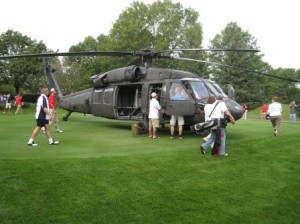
top-left (148, 92), bottom-right (163, 139)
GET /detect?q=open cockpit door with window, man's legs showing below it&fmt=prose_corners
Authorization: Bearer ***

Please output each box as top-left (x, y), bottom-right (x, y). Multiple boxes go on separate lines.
top-left (166, 82), bottom-right (195, 115)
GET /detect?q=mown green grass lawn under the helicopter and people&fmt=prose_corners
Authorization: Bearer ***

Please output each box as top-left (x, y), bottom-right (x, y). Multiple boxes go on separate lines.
top-left (0, 109), bottom-right (300, 224)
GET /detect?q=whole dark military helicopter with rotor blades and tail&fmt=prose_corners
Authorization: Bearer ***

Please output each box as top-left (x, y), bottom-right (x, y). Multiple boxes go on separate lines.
top-left (0, 48), bottom-right (296, 133)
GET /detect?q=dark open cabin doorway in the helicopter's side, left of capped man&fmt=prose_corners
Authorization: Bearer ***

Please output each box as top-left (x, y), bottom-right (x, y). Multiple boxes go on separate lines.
top-left (115, 85), bottom-right (142, 120)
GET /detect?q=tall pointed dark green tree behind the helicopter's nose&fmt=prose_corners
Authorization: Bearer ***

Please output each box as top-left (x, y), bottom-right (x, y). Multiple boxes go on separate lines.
top-left (210, 22), bottom-right (271, 102)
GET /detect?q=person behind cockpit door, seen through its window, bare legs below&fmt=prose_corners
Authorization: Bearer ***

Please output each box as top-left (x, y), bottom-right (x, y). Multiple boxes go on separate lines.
top-left (170, 86), bottom-right (186, 140)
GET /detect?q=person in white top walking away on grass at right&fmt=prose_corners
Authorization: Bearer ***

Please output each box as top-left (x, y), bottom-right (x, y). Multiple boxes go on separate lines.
top-left (268, 96), bottom-right (282, 136)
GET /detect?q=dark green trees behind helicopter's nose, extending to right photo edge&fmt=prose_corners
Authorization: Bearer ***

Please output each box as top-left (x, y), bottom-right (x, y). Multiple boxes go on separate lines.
top-left (209, 22), bottom-right (299, 108)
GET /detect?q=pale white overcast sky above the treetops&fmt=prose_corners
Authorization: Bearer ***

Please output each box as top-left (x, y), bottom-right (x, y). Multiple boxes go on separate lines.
top-left (0, 0), bottom-right (300, 69)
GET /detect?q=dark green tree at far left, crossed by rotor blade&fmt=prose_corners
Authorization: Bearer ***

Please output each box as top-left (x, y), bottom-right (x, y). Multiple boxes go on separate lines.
top-left (0, 30), bottom-right (46, 93)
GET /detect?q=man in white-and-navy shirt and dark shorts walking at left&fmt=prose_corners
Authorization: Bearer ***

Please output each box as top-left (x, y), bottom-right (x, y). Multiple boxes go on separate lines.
top-left (27, 87), bottom-right (59, 146)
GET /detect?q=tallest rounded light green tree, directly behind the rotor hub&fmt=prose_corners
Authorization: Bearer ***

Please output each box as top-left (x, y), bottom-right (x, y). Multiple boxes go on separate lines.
top-left (109, 0), bottom-right (203, 70)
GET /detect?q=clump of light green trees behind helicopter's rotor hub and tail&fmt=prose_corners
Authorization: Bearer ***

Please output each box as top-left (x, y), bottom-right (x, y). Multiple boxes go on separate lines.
top-left (64, 0), bottom-right (203, 91)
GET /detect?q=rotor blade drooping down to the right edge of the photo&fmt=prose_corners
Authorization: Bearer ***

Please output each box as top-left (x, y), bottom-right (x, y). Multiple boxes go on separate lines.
top-left (174, 57), bottom-right (300, 83)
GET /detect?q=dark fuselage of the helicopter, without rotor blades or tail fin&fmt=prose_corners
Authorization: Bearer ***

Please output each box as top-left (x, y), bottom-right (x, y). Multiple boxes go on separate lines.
top-left (54, 66), bottom-right (244, 125)
